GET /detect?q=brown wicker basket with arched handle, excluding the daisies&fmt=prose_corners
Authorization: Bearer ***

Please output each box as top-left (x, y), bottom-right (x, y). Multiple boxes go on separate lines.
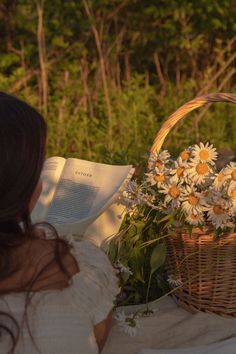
top-left (151, 93), bottom-right (236, 317)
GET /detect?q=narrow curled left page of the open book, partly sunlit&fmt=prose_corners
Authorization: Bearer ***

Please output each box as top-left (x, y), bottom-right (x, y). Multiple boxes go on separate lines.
top-left (31, 156), bottom-right (66, 222)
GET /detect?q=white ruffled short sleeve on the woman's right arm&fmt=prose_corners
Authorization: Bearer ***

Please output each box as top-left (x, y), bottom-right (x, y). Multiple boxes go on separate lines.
top-left (64, 235), bottom-right (119, 325)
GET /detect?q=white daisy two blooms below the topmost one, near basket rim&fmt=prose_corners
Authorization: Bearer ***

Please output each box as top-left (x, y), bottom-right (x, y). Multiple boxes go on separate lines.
top-left (181, 185), bottom-right (206, 214)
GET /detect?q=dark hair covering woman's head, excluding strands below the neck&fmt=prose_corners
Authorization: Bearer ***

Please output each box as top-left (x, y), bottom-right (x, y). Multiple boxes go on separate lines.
top-left (0, 93), bottom-right (47, 223)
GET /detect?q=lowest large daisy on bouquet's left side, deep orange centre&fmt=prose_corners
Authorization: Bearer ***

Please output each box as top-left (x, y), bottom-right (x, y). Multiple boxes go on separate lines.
top-left (159, 177), bottom-right (184, 209)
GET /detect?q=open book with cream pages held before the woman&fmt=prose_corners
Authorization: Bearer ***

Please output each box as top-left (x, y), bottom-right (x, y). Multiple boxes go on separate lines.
top-left (31, 157), bottom-right (134, 235)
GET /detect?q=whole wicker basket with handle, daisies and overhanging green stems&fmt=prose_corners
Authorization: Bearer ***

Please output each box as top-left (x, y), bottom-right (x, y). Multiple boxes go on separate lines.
top-left (109, 93), bottom-right (236, 316)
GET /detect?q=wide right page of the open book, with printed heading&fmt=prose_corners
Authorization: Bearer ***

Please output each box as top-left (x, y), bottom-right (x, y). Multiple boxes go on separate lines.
top-left (47, 158), bottom-right (132, 232)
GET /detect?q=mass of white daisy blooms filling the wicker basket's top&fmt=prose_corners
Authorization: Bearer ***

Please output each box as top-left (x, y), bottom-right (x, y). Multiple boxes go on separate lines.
top-left (142, 143), bottom-right (236, 235)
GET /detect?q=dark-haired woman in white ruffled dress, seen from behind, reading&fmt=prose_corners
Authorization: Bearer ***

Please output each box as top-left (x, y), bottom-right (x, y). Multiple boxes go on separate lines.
top-left (0, 93), bottom-right (118, 354)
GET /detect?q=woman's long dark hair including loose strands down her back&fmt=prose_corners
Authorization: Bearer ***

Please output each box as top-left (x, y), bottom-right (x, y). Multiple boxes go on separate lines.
top-left (0, 92), bottom-right (69, 352)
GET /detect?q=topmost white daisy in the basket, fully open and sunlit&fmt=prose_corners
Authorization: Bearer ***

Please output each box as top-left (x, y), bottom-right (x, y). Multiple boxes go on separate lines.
top-left (192, 143), bottom-right (217, 165)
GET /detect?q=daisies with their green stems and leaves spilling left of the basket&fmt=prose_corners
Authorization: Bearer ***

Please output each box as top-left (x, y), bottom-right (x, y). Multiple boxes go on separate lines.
top-left (113, 142), bottom-right (236, 304)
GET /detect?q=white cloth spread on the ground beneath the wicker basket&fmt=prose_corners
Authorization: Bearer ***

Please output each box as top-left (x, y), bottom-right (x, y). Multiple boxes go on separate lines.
top-left (102, 297), bottom-right (236, 354)
